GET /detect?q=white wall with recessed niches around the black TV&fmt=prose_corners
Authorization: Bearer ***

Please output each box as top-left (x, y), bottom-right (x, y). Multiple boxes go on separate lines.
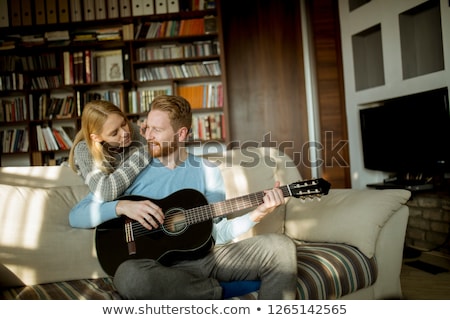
top-left (339, 0), bottom-right (450, 189)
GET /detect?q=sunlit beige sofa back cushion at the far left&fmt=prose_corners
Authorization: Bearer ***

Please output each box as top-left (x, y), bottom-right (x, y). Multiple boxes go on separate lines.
top-left (0, 185), bottom-right (106, 287)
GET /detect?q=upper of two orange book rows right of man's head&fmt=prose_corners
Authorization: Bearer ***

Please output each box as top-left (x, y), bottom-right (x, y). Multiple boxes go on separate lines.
top-left (178, 83), bottom-right (223, 109)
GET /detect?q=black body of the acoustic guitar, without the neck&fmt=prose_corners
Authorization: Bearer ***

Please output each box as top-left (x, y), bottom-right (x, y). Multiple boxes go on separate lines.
top-left (95, 189), bottom-right (214, 276)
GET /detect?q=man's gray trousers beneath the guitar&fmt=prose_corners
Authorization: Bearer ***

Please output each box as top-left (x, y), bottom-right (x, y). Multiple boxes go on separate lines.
top-left (114, 234), bottom-right (297, 300)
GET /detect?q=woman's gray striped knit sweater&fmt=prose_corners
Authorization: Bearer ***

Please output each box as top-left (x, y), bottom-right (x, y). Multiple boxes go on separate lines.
top-left (74, 124), bottom-right (150, 201)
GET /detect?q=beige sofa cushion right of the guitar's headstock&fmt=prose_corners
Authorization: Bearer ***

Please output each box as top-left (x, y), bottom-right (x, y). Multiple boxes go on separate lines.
top-left (285, 189), bottom-right (411, 258)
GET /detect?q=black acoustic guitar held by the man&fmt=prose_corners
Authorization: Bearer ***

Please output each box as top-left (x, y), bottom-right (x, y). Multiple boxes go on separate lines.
top-left (95, 178), bottom-right (330, 276)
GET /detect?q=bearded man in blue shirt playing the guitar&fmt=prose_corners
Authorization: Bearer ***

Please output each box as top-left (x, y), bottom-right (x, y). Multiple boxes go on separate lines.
top-left (70, 96), bottom-right (297, 299)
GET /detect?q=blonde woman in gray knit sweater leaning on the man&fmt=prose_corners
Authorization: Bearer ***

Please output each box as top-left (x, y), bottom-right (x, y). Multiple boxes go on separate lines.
top-left (69, 100), bottom-right (149, 201)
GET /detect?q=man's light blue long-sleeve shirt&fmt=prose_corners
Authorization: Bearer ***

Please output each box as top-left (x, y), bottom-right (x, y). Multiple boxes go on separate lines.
top-left (69, 155), bottom-right (255, 244)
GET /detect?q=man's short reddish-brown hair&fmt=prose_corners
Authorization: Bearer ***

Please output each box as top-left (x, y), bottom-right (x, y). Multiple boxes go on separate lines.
top-left (150, 95), bottom-right (192, 131)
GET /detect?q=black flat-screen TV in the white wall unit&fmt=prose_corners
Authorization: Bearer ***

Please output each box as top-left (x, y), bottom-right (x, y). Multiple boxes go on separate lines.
top-left (360, 88), bottom-right (450, 177)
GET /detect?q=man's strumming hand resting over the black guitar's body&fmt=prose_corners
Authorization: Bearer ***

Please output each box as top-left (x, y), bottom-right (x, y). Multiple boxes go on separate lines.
top-left (116, 200), bottom-right (164, 230)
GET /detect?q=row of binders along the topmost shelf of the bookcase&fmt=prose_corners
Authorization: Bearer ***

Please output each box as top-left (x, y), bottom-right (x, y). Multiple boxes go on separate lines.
top-left (0, 0), bottom-right (215, 28)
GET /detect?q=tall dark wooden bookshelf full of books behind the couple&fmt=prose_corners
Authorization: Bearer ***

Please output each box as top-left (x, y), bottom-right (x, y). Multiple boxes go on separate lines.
top-left (0, 0), bottom-right (228, 166)
